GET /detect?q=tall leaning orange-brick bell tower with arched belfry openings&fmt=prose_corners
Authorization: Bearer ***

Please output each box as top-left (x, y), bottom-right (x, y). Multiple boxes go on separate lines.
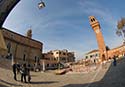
top-left (89, 16), bottom-right (107, 61)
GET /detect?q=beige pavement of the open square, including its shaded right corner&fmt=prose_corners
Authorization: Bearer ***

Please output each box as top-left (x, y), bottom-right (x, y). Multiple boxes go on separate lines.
top-left (0, 57), bottom-right (125, 87)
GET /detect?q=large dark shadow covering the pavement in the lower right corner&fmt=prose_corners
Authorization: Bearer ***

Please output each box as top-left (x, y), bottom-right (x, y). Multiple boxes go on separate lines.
top-left (63, 59), bottom-right (125, 87)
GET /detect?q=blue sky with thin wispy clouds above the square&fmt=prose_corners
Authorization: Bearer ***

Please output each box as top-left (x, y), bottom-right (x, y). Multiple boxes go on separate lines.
top-left (3, 0), bottom-right (125, 59)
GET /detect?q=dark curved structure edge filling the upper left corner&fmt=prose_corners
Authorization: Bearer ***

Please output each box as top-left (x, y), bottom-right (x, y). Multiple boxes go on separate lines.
top-left (0, 0), bottom-right (20, 29)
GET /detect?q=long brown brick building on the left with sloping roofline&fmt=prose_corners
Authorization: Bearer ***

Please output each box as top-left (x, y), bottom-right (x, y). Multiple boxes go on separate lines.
top-left (0, 28), bottom-right (43, 65)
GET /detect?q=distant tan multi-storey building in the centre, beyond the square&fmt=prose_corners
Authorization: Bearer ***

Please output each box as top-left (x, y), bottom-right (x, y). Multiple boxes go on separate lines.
top-left (42, 50), bottom-right (75, 68)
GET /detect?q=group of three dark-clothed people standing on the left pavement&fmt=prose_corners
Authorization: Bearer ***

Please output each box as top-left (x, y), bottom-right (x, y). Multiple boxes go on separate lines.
top-left (13, 63), bottom-right (31, 83)
